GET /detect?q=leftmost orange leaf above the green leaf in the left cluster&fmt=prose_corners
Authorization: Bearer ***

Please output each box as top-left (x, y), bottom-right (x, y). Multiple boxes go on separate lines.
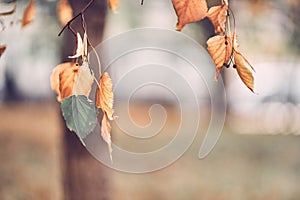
top-left (50, 62), bottom-right (80, 102)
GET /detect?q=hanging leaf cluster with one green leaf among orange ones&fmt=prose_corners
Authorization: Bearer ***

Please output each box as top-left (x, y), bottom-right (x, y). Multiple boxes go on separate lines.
top-left (51, 30), bottom-right (113, 159)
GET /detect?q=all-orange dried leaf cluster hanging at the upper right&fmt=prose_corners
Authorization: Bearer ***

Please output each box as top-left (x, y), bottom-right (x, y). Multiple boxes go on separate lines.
top-left (172, 0), bottom-right (255, 92)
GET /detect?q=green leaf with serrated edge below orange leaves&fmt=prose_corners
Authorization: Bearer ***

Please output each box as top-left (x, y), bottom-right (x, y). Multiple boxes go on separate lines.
top-left (61, 95), bottom-right (99, 146)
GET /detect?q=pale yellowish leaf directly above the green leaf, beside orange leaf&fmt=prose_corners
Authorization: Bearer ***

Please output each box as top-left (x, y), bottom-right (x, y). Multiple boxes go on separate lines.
top-left (73, 60), bottom-right (94, 97)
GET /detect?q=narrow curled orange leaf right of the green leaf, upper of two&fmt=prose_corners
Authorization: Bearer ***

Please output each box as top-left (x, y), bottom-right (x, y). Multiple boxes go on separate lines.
top-left (96, 72), bottom-right (114, 120)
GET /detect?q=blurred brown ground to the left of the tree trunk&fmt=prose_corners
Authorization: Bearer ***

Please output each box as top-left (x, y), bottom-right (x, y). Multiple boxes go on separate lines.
top-left (0, 103), bottom-right (62, 200)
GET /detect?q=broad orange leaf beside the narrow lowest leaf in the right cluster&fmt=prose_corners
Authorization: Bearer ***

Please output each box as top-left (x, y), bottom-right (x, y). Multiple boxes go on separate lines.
top-left (207, 35), bottom-right (233, 80)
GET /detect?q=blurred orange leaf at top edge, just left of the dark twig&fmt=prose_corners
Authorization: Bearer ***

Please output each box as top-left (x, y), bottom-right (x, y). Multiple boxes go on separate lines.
top-left (56, 0), bottom-right (73, 26)
